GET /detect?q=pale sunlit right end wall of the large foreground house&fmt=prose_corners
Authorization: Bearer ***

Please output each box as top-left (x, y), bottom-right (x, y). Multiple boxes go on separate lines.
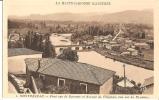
top-left (100, 77), bottom-right (113, 94)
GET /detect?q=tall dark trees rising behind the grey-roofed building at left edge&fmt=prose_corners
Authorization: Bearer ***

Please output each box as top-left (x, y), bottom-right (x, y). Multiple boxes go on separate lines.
top-left (16, 31), bottom-right (56, 57)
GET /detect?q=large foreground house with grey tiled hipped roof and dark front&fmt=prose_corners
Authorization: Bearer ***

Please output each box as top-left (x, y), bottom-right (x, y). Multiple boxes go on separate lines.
top-left (25, 58), bottom-right (115, 94)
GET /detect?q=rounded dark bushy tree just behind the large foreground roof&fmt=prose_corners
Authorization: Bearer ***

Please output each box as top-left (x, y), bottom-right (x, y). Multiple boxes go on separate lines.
top-left (58, 48), bottom-right (79, 61)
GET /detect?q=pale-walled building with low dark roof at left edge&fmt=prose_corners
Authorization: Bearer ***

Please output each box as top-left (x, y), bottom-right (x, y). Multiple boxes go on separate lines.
top-left (8, 48), bottom-right (42, 74)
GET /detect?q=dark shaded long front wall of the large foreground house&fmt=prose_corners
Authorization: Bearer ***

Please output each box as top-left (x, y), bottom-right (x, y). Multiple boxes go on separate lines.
top-left (27, 72), bottom-right (99, 94)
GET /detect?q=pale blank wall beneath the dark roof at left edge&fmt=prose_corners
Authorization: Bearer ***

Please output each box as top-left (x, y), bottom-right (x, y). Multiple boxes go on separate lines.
top-left (8, 54), bottom-right (42, 74)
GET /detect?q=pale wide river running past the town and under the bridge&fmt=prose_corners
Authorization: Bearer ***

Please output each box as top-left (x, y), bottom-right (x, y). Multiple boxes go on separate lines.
top-left (50, 34), bottom-right (154, 83)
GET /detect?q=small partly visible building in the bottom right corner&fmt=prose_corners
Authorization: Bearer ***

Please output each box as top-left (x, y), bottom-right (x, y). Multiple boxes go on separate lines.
top-left (142, 77), bottom-right (154, 94)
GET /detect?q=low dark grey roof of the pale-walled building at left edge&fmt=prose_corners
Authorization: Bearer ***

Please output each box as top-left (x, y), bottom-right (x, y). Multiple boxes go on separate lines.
top-left (8, 48), bottom-right (42, 57)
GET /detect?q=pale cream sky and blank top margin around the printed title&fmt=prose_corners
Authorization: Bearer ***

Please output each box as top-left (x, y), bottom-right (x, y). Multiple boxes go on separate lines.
top-left (5, 0), bottom-right (154, 16)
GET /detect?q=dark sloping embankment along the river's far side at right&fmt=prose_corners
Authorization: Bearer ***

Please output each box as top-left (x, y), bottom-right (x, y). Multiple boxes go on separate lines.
top-left (94, 48), bottom-right (154, 70)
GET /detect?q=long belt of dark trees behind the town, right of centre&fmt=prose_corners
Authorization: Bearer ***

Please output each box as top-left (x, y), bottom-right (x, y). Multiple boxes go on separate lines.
top-left (71, 23), bottom-right (153, 42)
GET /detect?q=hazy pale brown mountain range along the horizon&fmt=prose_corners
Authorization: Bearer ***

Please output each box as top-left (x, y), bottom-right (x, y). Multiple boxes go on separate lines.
top-left (9, 9), bottom-right (153, 24)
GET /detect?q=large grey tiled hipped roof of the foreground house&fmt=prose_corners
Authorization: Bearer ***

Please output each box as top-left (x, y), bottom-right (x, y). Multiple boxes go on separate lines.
top-left (25, 58), bottom-right (115, 85)
